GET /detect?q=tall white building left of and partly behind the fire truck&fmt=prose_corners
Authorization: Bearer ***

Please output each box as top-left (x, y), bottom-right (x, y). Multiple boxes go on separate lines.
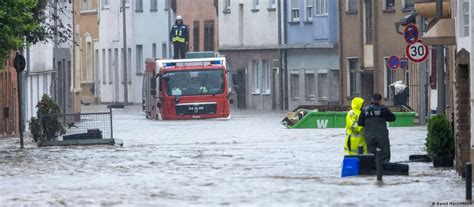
top-left (95, 0), bottom-right (170, 103)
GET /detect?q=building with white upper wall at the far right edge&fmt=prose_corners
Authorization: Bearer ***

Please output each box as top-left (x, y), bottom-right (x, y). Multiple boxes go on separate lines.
top-left (451, 0), bottom-right (474, 176)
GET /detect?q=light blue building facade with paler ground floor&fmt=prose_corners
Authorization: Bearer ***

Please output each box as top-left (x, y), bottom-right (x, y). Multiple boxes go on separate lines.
top-left (282, 0), bottom-right (339, 109)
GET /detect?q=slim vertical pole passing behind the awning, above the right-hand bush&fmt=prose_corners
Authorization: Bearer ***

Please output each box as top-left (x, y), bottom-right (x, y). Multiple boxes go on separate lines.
top-left (436, 0), bottom-right (446, 115)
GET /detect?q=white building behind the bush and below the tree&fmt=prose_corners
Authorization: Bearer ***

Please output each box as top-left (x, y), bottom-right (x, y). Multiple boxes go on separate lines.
top-left (23, 1), bottom-right (74, 118)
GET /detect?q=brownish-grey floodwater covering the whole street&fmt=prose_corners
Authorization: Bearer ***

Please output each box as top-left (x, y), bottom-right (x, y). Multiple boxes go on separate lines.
top-left (0, 106), bottom-right (465, 206)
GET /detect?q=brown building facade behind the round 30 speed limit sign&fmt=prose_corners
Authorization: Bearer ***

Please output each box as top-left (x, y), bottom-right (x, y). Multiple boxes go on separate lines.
top-left (339, 0), bottom-right (427, 111)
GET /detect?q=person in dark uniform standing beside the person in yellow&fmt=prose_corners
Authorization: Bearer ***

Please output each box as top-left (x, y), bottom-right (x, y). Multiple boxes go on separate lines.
top-left (358, 93), bottom-right (396, 162)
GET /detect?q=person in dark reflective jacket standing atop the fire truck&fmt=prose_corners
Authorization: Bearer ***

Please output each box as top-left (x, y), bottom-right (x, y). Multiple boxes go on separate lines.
top-left (170, 16), bottom-right (189, 59)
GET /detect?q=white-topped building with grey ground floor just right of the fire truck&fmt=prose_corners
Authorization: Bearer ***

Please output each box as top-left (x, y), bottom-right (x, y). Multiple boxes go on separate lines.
top-left (218, 0), bottom-right (281, 110)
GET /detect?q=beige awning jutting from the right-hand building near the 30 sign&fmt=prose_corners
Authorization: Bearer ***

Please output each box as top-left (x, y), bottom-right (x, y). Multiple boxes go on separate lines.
top-left (422, 19), bottom-right (456, 45)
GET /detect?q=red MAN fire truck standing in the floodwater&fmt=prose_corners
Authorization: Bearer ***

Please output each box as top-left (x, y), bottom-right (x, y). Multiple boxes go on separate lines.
top-left (143, 57), bottom-right (231, 120)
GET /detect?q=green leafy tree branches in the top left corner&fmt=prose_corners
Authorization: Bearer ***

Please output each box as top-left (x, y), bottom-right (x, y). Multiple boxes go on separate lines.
top-left (0, 0), bottom-right (72, 68)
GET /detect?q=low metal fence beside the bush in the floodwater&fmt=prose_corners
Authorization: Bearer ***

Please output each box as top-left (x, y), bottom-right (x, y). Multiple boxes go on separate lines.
top-left (37, 110), bottom-right (113, 141)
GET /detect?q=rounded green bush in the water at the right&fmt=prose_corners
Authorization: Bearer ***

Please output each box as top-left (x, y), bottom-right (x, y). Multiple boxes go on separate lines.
top-left (426, 115), bottom-right (454, 156)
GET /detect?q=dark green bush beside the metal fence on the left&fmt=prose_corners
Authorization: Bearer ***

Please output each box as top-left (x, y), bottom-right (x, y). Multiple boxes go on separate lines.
top-left (30, 94), bottom-right (65, 141)
